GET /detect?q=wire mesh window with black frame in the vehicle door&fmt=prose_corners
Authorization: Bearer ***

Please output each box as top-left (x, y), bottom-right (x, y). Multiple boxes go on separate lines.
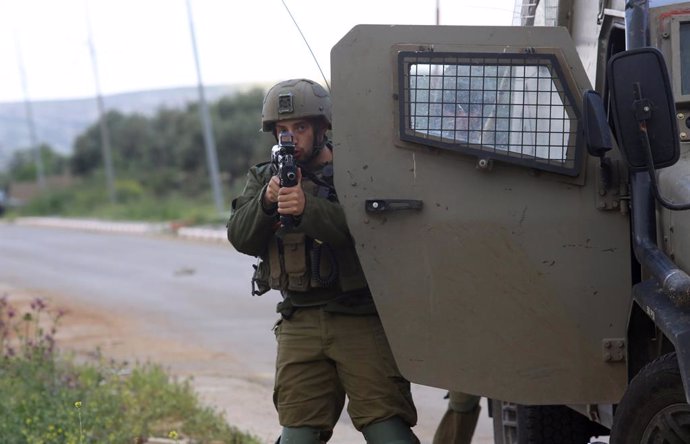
top-left (398, 52), bottom-right (579, 176)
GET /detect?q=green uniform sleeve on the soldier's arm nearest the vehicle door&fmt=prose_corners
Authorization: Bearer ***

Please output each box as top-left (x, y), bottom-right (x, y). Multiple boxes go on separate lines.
top-left (299, 196), bottom-right (352, 247)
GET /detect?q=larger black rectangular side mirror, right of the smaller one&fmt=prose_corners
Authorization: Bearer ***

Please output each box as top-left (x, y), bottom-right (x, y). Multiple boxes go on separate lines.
top-left (607, 48), bottom-right (680, 171)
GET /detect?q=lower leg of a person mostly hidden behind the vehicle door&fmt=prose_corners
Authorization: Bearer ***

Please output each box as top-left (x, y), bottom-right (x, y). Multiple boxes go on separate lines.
top-left (433, 392), bottom-right (480, 444)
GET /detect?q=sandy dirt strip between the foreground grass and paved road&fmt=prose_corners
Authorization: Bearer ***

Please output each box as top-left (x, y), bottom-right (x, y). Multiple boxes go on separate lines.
top-left (0, 283), bottom-right (279, 443)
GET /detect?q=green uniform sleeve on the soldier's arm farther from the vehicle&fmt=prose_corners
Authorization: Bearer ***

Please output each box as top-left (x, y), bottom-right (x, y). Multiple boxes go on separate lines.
top-left (227, 166), bottom-right (278, 256)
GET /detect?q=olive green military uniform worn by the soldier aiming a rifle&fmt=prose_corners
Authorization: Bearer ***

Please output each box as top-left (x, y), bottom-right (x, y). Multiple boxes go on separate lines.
top-left (228, 157), bottom-right (417, 443)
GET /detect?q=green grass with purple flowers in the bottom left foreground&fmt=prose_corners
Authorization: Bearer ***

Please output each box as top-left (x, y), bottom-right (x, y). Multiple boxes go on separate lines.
top-left (0, 296), bottom-right (259, 444)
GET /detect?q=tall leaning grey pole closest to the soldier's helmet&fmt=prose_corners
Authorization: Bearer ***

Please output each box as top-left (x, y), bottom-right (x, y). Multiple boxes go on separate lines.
top-left (185, 0), bottom-right (224, 214)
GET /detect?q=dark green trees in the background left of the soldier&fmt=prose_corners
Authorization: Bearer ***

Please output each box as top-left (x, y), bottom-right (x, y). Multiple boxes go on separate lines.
top-left (4, 88), bottom-right (274, 195)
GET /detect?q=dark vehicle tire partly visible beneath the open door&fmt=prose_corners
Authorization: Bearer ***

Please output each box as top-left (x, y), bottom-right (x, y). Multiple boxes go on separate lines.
top-left (491, 400), bottom-right (599, 444)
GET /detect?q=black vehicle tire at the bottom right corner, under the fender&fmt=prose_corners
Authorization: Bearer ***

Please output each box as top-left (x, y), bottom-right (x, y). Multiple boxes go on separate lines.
top-left (611, 353), bottom-right (690, 444)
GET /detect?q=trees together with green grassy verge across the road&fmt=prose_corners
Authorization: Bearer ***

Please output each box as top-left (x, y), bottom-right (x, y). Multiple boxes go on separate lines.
top-left (0, 89), bottom-right (274, 224)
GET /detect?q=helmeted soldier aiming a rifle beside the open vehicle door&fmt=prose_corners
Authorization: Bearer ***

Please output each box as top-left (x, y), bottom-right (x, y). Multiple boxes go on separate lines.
top-left (228, 79), bottom-right (419, 444)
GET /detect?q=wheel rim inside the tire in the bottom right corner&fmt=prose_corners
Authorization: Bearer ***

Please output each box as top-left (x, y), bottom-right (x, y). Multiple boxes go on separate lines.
top-left (641, 403), bottom-right (690, 444)
